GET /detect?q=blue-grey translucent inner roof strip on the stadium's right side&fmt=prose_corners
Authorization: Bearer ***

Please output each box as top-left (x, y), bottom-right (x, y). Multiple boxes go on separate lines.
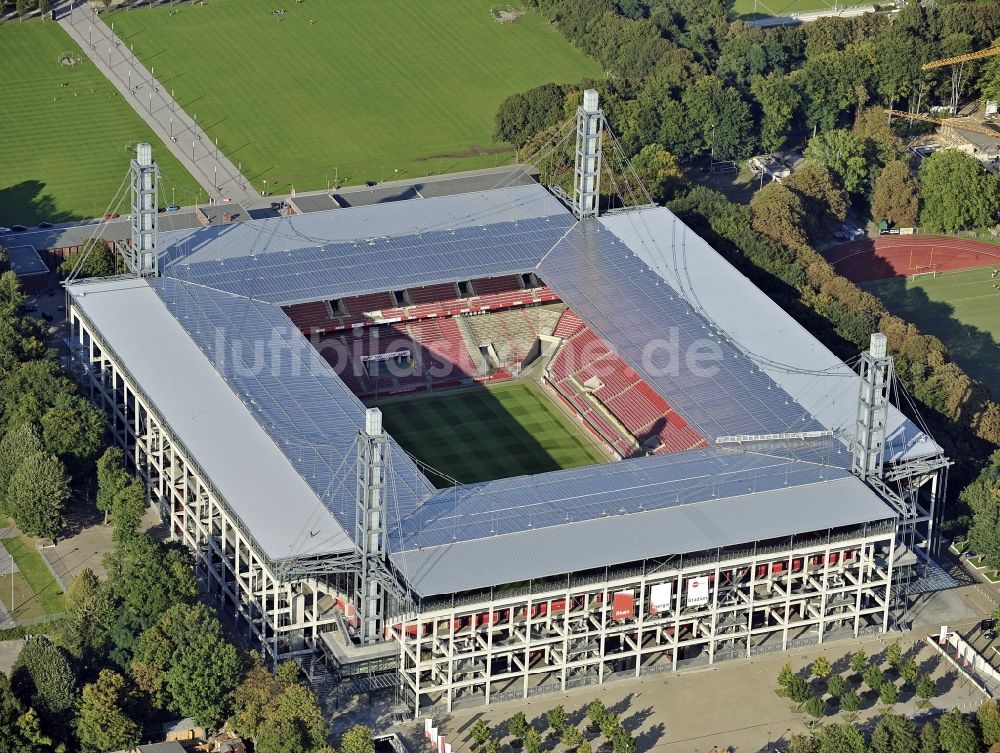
top-left (538, 221), bottom-right (824, 441)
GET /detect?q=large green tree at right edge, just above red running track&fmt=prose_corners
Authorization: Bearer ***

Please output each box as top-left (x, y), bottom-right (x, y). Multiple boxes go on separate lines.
top-left (919, 149), bottom-right (1000, 232)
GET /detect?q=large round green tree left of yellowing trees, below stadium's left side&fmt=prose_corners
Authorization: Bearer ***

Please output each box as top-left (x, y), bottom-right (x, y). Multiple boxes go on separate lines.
top-left (132, 604), bottom-right (241, 725)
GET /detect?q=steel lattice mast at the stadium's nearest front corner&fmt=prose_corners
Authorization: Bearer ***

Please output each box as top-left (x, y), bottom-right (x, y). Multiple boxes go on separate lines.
top-left (354, 408), bottom-right (389, 644)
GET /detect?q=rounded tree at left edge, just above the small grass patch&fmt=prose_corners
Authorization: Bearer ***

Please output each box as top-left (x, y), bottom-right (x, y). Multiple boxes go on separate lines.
top-left (7, 452), bottom-right (70, 539)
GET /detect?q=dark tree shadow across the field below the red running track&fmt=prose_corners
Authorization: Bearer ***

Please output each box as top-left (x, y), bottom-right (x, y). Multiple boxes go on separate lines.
top-left (872, 278), bottom-right (1000, 395)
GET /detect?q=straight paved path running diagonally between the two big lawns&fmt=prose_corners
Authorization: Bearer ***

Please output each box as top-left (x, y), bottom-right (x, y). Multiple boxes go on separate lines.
top-left (59, 4), bottom-right (260, 206)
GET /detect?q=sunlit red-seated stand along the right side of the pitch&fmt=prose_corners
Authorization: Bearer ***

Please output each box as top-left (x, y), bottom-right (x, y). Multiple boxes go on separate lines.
top-left (545, 309), bottom-right (707, 457)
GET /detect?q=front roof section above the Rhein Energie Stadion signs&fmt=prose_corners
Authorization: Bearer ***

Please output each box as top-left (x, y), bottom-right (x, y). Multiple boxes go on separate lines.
top-left (391, 468), bottom-right (895, 597)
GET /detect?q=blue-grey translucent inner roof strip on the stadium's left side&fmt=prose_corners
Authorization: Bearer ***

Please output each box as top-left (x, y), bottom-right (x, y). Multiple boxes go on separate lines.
top-left (154, 278), bottom-right (433, 536)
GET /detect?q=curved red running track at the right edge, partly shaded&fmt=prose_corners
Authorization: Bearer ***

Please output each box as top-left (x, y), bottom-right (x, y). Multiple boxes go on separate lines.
top-left (823, 235), bottom-right (1000, 282)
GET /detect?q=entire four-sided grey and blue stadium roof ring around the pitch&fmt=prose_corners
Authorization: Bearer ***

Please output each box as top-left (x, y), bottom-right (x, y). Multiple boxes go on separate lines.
top-left (71, 176), bottom-right (940, 595)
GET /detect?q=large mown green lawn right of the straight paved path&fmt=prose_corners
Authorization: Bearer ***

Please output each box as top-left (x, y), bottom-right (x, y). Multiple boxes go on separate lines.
top-left (110, 0), bottom-right (601, 193)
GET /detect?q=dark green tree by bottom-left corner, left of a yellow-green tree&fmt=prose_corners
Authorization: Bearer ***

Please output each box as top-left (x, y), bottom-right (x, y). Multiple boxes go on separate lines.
top-left (10, 635), bottom-right (77, 739)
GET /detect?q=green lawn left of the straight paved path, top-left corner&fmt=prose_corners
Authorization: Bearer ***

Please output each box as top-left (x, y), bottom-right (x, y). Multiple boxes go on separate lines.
top-left (0, 21), bottom-right (198, 225)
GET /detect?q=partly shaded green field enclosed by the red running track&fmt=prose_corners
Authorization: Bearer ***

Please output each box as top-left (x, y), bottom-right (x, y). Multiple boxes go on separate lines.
top-left (863, 267), bottom-right (1000, 395)
